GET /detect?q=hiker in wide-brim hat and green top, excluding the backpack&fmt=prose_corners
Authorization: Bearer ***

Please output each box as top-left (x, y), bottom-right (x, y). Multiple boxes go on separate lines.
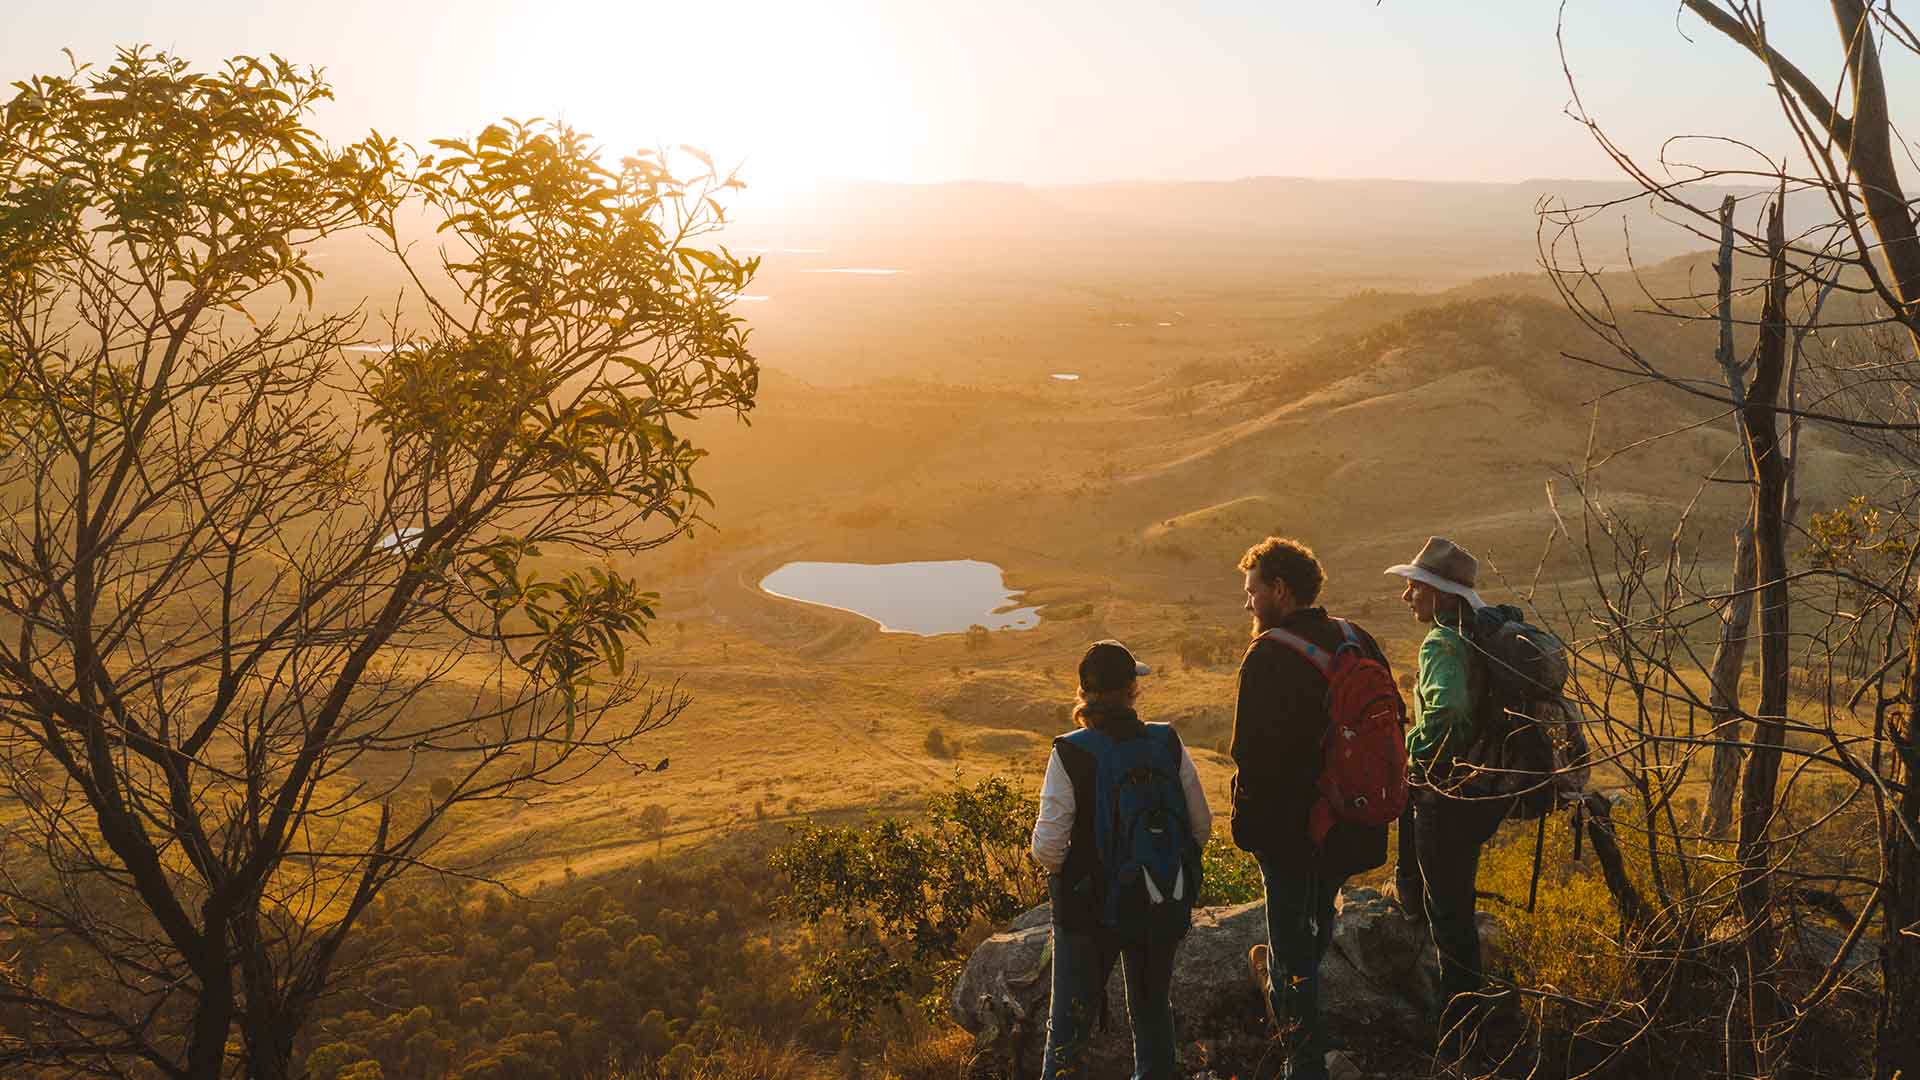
top-left (1386, 536), bottom-right (1507, 1042)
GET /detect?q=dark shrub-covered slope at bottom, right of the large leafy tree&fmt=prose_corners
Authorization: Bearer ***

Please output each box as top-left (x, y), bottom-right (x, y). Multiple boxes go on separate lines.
top-left (294, 836), bottom-right (825, 1080)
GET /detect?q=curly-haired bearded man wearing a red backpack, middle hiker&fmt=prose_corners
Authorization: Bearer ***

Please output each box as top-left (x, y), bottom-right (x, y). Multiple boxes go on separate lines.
top-left (1229, 536), bottom-right (1407, 1080)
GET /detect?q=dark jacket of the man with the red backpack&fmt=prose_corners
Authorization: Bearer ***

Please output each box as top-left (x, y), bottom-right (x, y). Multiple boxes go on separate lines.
top-left (1229, 607), bottom-right (1386, 861)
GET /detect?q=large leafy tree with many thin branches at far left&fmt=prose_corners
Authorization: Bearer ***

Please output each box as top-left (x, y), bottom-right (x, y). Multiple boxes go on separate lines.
top-left (0, 50), bottom-right (758, 1078)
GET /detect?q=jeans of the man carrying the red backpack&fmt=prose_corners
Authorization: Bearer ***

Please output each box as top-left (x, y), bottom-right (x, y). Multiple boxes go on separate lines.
top-left (1260, 855), bottom-right (1346, 1080)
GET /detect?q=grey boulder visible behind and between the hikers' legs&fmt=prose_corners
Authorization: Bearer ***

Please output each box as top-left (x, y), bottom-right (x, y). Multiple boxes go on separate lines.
top-left (952, 888), bottom-right (1492, 1076)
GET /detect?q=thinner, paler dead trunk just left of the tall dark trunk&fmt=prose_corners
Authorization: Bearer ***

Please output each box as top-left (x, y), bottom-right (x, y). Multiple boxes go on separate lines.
top-left (1705, 196), bottom-right (1755, 836)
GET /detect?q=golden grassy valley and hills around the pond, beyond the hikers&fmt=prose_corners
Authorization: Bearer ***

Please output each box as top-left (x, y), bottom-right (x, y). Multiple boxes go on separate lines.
top-left (341, 203), bottom-right (1868, 884)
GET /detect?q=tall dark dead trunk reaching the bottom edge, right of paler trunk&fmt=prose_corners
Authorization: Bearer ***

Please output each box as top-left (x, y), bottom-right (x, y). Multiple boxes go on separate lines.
top-left (1736, 204), bottom-right (1788, 1076)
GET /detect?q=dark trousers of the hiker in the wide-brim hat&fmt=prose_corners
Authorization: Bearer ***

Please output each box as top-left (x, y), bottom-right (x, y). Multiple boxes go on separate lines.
top-left (1394, 792), bottom-right (1505, 1032)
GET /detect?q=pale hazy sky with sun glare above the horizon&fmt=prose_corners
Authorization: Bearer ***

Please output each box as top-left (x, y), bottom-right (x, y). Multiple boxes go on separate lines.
top-left (0, 0), bottom-right (1914, 190)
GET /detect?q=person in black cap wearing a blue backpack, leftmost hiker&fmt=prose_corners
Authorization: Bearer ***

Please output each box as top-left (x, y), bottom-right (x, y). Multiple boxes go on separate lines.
top-left (1033, 640), bottom-right (1213, 1080)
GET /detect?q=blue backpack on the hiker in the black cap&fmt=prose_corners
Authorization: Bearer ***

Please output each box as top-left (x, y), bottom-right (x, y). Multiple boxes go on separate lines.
top-left (1062, 724), bottom-right (1200, 942)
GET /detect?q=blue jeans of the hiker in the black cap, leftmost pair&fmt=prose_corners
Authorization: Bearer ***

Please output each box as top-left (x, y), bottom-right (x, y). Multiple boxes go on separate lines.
top-left (1041, 914), bottom-right (1181, 1080)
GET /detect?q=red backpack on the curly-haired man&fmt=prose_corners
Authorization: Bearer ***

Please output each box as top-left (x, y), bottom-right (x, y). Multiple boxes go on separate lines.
top-left (1263, 619), bottom-right (1407, 847)
